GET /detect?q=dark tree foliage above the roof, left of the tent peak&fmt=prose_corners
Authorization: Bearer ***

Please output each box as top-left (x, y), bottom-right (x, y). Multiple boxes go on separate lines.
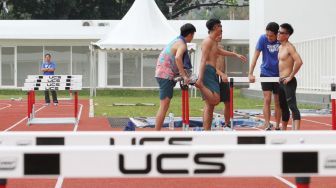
top-left (6, 0), bottom-right (134, 19)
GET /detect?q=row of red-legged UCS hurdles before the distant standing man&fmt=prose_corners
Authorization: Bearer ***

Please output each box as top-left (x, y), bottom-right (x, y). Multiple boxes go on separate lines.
top-left (22, 75), bottom-right (82, 126)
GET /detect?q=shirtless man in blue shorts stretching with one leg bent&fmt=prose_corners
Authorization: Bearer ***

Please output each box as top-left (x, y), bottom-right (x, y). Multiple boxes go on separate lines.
top-left (195, 19), bottom-right (246, 130)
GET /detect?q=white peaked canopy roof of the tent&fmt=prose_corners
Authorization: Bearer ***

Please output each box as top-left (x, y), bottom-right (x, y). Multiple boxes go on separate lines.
top-left (95, 0), bottom-right (178, 50)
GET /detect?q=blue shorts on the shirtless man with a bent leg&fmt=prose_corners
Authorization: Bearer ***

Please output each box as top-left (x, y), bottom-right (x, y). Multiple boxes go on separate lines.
top-left (203, 64), bottom-right (220, 94)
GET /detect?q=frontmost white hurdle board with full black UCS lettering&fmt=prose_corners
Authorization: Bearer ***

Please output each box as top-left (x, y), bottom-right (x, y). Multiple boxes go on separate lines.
top-left (0, 145), bottom-right (336, 178)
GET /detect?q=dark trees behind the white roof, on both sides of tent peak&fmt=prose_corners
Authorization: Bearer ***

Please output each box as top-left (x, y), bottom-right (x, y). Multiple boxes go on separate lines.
top-left (1, 0), bottom-right (248, 20)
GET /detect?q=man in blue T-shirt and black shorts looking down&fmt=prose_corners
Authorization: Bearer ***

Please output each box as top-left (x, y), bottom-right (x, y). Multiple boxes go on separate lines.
top-left (249, 22), bottom-right (281, 130)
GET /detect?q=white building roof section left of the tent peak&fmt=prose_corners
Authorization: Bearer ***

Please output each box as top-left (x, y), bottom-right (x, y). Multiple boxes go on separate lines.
top-left (0, 20), bottom-right (115, 39)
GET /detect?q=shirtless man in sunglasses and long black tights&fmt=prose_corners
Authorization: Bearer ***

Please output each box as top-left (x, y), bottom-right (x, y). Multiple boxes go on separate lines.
top-left (278, 23), bottom-right (303, 130)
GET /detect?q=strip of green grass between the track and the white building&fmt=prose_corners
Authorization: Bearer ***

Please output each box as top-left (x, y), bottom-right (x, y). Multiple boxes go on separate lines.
top-left (0, 89), bottom-right (320, 117)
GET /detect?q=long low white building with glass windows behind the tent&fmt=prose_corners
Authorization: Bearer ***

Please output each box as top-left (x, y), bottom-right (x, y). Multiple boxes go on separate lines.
top-left (0, 0), bottom-right (249, 88)
